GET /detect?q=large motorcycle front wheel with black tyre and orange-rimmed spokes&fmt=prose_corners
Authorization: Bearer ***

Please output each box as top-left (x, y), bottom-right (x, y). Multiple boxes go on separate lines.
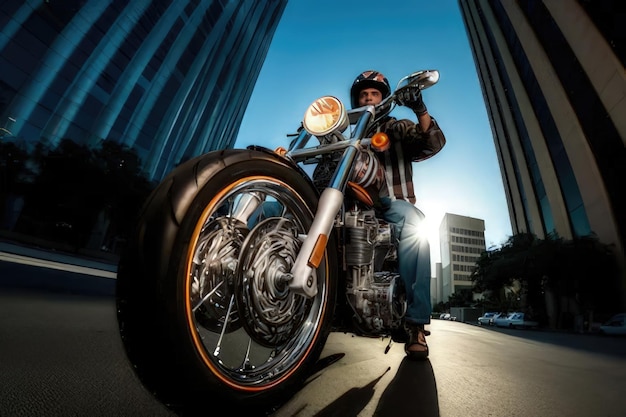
top-left (117, 150), bottom-right (337, 415)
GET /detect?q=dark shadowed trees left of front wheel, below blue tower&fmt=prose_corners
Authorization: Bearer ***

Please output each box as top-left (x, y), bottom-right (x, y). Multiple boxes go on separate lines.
top-left (11, 139), bottom-right (154, 250)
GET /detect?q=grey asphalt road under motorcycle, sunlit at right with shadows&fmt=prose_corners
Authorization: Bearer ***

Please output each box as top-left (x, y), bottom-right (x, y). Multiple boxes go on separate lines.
top-left (0, 261), bottom-right (626, 417)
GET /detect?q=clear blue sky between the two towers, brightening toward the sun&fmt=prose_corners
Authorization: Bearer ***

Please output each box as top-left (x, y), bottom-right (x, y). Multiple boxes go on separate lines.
top-left (235, 0), bottom-right (512, 265)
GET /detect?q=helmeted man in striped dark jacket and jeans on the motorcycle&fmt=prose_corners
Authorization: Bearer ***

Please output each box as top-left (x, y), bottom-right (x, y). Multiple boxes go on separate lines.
top-left (350, 70), bottom-right (446, 360)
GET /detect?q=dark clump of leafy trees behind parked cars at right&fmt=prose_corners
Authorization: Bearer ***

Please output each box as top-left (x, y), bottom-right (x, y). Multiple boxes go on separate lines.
top-left (471, 233), bottom-right (622, 322)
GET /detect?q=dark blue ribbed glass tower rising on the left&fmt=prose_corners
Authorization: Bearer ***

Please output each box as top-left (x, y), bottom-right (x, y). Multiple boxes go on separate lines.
top-left (0, 0), bottom-right (286, 256)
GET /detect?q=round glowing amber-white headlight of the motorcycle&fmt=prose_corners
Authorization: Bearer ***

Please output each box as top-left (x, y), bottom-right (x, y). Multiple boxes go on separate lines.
top-left (302, 96), bottom-right (349, 136)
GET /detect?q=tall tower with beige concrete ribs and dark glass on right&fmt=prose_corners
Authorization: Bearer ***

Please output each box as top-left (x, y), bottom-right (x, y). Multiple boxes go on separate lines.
top-left (459, 0), bottom-right (626, 272)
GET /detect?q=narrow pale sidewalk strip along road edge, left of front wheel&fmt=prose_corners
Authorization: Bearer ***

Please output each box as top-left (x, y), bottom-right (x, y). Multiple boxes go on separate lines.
top-left (0, 241), bottom-right (117, 279)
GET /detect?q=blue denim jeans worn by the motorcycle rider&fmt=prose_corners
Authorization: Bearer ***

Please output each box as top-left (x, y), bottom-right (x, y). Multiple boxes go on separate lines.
top-left (381, 197), bottom-right (431, 325)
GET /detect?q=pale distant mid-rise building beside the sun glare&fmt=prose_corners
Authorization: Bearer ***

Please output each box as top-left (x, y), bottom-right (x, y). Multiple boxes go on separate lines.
top-left (437, 213), bottom-right (485, 302)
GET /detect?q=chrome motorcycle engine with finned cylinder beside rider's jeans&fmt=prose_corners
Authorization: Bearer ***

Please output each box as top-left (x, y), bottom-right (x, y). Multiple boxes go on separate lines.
top-left (344, 209), bottom-right (406, 334)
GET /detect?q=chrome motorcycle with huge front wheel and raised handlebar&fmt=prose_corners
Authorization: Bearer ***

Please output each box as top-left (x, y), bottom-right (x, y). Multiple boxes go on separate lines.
top-left (116, 70), bottom-right (439, 414)
